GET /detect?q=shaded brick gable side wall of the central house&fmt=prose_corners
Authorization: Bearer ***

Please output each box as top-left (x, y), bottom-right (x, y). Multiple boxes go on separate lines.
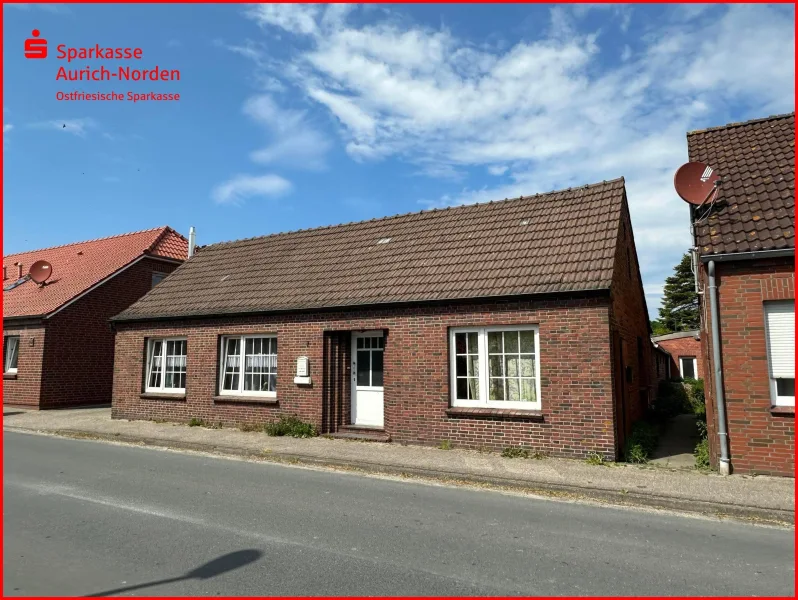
top-left (601, 199), bottom-right (655, 445)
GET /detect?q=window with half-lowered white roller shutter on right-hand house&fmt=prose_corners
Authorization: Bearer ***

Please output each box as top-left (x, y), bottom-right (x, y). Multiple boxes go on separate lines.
top-left (765, 300), bottom-right (795, 406)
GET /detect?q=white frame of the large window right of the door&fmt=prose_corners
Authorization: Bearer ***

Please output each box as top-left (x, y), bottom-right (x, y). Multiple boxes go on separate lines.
top-left (449, 325), bottom-right (542, 410)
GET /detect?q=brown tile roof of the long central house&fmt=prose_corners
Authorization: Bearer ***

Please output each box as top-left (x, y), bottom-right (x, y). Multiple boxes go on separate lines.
top-left (115, 179), bottom-right (625, 320)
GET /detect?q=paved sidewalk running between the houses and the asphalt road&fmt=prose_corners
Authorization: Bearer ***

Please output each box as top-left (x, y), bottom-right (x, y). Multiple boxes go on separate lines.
top-left (3, 407), bottom-right (795, 523)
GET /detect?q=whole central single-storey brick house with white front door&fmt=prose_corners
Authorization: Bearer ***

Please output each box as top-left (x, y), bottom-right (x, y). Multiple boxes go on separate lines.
top-left (112, 179), bottom-right (651, 459)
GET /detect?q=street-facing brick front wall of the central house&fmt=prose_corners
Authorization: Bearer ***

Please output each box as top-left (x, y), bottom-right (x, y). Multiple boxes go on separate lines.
top-left (112, 296), bottom-right (616, 460)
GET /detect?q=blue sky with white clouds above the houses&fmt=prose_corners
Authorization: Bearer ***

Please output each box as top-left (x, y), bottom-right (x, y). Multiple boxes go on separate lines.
top-left (3, 4), bottom-right (795, 316)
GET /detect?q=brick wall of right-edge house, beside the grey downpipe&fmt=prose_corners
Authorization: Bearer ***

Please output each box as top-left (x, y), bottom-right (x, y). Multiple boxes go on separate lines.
top-left (700, 258), bottom-right (795, 476)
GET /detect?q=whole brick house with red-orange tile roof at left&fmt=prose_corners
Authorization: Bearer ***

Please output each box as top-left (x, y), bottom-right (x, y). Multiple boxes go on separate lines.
top-left (3, 227), bottom-right (188, 408)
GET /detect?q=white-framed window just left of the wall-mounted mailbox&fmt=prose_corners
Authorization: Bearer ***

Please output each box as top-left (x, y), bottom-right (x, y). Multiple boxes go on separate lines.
top-left (219, 335), bottom-right (277, 397)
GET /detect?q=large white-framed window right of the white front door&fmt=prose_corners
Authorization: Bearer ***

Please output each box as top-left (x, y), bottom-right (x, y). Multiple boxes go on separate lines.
top-left (450, 326), bottom-right (540, 410)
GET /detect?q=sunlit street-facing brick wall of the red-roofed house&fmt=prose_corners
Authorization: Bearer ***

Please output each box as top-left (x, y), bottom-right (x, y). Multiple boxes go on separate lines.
top-left (3, 323), bottom-right (45, 408)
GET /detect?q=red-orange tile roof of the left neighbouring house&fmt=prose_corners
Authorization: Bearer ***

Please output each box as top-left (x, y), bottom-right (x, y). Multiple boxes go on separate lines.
top-left (3, 227), bottom-right (188, 318)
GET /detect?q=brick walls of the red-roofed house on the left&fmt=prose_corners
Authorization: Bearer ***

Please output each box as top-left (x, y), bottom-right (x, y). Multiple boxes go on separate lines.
top-left (3, 258), bottom-right (178, 409)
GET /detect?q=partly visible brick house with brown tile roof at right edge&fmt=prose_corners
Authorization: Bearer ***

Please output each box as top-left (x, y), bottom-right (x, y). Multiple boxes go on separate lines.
top-left (687, 113), bottom-right (795, 476)
